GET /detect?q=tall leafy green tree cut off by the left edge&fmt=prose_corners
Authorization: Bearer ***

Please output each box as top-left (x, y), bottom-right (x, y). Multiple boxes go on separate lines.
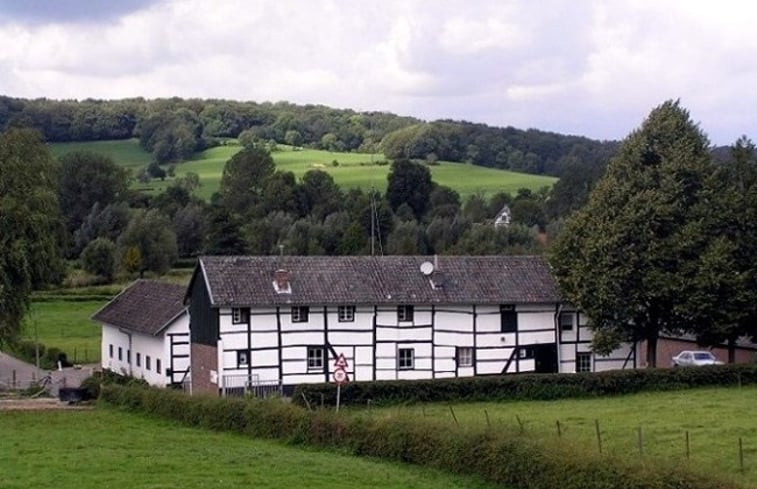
top-left (0, 130), bottom-right (63, 343)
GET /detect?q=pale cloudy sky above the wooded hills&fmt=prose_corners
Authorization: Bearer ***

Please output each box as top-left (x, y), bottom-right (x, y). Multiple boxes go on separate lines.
top-left (0, 0), bottom-right (757, 145)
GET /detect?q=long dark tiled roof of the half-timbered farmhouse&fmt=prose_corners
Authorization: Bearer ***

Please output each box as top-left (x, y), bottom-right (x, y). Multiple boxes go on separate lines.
top-left (198, 256), bottom-right (560, 307)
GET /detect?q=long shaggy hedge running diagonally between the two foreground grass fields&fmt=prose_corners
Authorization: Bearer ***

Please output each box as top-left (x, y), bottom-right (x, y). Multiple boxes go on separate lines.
top-left (100, 385), bottom-right (738, 489)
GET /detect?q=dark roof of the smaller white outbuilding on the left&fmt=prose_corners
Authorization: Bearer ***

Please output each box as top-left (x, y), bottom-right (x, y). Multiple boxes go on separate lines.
top-left (92, 280), bottom-right (186, 335)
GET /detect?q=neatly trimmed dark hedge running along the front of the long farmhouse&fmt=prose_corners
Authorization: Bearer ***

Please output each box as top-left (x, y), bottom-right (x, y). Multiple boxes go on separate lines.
top-left (293, 364), bottom-right (757, 406)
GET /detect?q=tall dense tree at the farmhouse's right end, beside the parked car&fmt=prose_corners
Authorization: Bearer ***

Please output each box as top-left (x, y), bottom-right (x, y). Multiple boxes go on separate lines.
top-left (551, 101), bottom-right (716, 366)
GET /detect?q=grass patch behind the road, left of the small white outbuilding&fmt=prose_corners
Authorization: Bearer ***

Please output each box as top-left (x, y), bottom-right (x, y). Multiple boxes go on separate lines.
top-left (23, 300), bottom-right (107, 363)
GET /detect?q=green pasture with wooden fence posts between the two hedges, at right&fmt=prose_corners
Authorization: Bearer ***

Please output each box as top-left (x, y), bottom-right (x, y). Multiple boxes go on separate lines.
top-left (364, 386), bottom-right (757, 487)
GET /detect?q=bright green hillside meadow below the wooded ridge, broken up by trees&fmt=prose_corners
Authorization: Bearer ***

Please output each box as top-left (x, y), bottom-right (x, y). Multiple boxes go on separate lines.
top-left (50, 139), bottom-right (557, 200)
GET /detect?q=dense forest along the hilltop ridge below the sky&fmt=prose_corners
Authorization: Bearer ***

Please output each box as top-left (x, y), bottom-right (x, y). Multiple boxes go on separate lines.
top-left (0, 97), bottom-right (616, 176)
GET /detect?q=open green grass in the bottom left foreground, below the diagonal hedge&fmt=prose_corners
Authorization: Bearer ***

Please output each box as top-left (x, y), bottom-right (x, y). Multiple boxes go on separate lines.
top-left (0, 408), bottom-right (500, 489)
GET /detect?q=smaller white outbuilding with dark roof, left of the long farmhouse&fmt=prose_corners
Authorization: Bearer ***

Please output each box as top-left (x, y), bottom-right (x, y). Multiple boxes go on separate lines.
top-left (92, 280), bottom-right (189, 387)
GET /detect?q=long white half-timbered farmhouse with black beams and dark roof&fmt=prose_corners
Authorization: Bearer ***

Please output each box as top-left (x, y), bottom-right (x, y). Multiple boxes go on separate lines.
top-left (186, 256), bottom-right (636, 393)
